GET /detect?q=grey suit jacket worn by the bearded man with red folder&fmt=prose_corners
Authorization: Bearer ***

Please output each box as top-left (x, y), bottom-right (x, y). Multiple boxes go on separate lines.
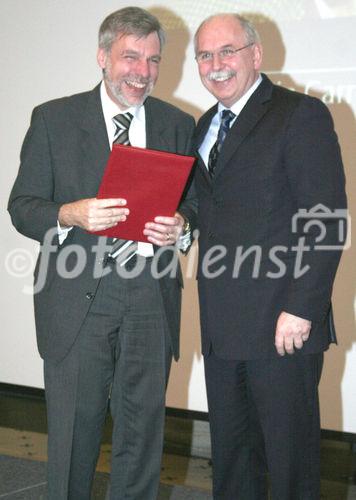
top-left (8, 86), bottom-right (195, 360)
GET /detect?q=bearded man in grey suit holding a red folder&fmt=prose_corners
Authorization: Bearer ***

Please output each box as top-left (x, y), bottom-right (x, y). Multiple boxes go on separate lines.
top-left (9, 7), bottom-right (195, 500)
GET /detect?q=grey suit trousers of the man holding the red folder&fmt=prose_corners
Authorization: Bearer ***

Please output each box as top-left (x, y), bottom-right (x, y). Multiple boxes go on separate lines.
top-left (45, 258), bottom-right (171, 500)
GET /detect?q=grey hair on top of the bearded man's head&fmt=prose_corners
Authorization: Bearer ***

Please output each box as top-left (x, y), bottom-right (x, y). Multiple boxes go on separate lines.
top-left (99, 7), bottom-right (166, 53)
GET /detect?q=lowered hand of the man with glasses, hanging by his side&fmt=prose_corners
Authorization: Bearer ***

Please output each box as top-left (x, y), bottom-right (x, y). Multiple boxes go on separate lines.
top-left (275, 311), bottom-right (311, 356)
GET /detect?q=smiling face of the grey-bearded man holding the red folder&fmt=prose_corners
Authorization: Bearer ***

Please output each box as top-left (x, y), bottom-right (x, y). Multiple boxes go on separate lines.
top-left (97, 32), bottom-right (161, 110)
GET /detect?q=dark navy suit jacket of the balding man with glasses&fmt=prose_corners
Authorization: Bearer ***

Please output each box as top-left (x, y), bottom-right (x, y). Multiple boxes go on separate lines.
top-left (195, 75), bottom-right (346, 359)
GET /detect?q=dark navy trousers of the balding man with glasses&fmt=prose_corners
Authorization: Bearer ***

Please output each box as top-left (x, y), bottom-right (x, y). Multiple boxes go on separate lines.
top-left (205, 352), bottom-right (323, 500)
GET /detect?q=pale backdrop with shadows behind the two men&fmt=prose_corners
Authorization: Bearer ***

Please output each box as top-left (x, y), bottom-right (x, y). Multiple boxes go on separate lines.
top-left (0, 0), bottom-right (356, 433)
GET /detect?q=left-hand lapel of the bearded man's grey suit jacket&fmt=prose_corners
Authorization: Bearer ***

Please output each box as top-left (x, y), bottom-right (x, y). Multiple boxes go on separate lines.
top-left (81, 84), bottom-right (110, 196)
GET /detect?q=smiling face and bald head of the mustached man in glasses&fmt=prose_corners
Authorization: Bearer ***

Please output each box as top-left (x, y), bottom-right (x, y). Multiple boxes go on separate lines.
top-left (196, 15), bottom-right (262, 108)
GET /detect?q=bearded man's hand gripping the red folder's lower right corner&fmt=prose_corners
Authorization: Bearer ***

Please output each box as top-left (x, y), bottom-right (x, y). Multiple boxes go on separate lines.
top-left (143, 212), bottom-right (184, 247)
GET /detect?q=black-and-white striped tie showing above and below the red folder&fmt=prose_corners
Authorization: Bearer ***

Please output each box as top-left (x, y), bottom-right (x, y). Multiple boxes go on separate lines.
top-left (109, 113), bottom-right (137, 266)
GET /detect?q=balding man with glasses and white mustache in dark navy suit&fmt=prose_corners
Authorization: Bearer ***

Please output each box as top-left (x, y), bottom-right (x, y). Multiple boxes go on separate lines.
top-left (195, 14), bottom-right (346, 500)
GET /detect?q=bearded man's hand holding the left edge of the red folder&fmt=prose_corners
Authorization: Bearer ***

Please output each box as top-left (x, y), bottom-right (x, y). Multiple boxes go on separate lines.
top-left (58, 198), bottom-right (129, 231)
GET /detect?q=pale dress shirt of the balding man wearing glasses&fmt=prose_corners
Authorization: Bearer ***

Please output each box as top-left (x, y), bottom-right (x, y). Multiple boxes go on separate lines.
top-left (199, 75), bottom-right (262, 168)
